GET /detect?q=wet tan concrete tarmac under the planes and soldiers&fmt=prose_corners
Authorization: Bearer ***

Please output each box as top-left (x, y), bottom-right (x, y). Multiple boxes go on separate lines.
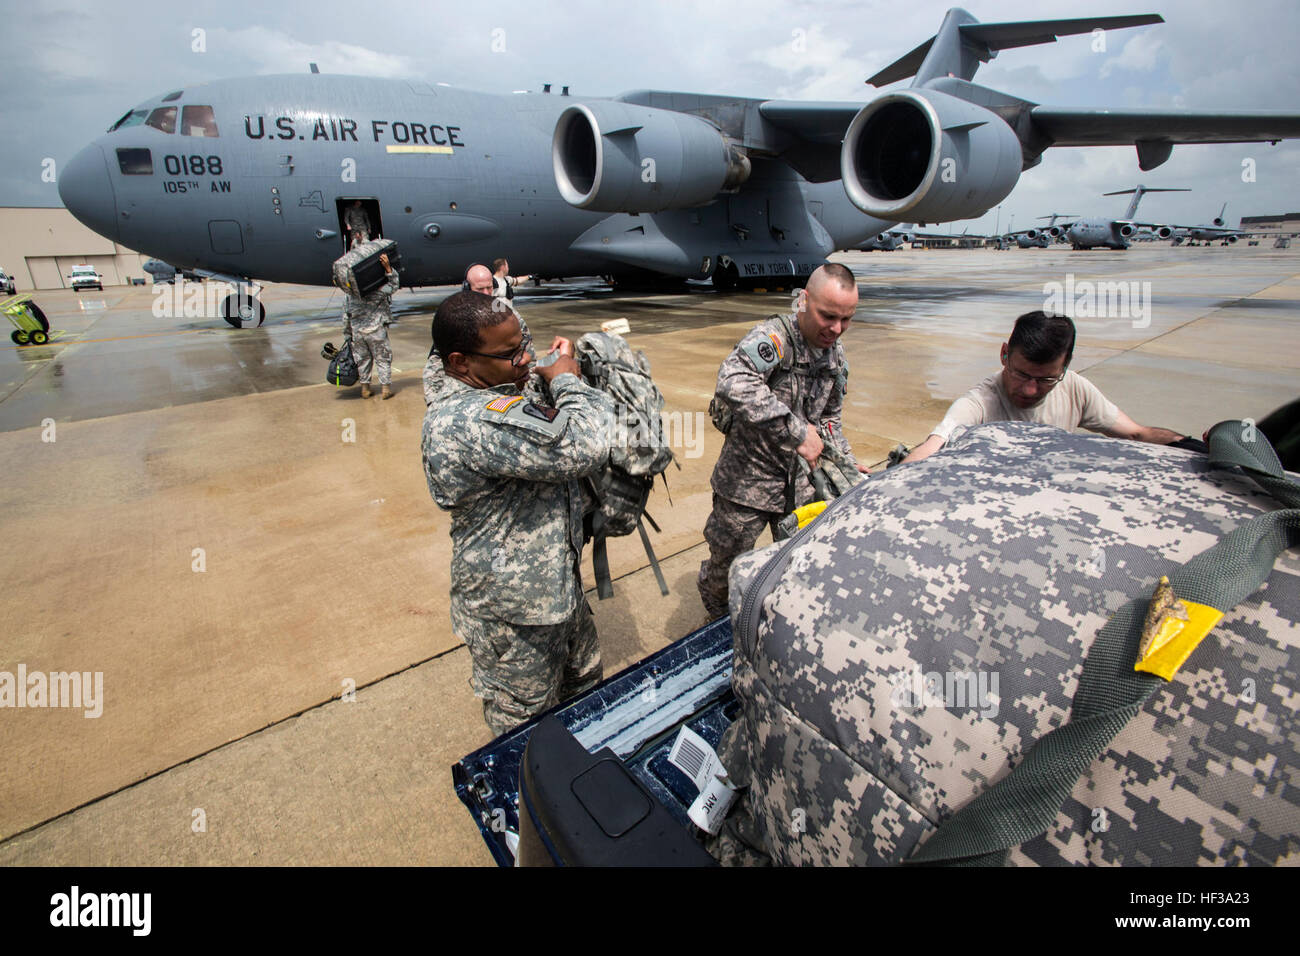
top-left (0, 246), bottom-right (1300, 865)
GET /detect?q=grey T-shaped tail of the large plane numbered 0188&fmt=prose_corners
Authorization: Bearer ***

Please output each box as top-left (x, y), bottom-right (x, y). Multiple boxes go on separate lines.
top-left (867, 7), bottom-right (1165, 87)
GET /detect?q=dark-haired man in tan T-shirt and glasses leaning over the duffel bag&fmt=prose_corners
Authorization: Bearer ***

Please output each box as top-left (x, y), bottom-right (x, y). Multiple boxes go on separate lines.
top-left (904, 312), bottom-right (1184, 464)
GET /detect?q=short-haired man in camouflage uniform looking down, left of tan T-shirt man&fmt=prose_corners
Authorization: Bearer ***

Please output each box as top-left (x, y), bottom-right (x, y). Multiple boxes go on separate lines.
top-left (697, 264), bottom-right (866, 618)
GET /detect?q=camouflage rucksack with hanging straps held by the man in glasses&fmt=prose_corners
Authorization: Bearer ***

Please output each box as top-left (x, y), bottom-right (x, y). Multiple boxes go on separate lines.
top-left (576, 332), bottom-right (681, 600)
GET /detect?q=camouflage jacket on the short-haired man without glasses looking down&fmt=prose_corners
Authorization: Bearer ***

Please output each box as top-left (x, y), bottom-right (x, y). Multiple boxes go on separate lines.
top-left (711, 315), bottom-right (852, 511)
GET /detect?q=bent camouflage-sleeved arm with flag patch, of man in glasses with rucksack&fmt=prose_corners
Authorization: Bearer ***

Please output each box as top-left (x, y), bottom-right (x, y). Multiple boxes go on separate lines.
top-left (465, 373), bottom-right (614, 481)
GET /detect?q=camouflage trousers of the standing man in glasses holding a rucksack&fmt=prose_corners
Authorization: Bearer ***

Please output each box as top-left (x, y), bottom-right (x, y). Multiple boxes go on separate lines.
top-left (451, 597), bottom-right (603, 736)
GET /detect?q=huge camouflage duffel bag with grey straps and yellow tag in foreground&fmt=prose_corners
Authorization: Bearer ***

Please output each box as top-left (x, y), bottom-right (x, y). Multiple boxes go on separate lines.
top-left (711, 423), bottom-right (1300, 865)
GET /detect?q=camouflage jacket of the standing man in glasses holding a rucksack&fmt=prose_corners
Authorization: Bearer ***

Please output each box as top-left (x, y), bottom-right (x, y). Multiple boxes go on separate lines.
top-left (421, 375), bottom-right (614, 624)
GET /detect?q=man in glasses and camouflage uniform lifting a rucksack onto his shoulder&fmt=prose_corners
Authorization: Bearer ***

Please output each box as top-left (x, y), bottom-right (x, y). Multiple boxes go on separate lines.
top-left (423, 293), bottom-right (614, 735)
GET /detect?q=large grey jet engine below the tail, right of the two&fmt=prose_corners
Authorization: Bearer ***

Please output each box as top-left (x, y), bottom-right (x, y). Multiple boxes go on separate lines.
top-left (840, 90), bottom-right (1023, 222)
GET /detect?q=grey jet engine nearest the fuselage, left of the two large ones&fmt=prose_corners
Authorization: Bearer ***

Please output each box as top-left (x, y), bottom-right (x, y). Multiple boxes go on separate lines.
top-left (551, 100), bottom-right (750, 212)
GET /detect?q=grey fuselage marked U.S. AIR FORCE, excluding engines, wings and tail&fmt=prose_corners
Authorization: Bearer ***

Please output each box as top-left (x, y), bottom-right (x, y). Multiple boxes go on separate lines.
top-left (60, 74), bottom-right (892, 286)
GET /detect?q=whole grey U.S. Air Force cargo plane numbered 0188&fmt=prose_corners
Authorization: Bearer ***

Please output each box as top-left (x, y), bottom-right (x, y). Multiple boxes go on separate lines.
top-left (59, 8), bottom-right (1300, 326)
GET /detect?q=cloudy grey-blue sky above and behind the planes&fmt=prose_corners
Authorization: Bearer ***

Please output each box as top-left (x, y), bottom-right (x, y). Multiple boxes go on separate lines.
top-left (10, 0), bottom-right (1300, 232)
